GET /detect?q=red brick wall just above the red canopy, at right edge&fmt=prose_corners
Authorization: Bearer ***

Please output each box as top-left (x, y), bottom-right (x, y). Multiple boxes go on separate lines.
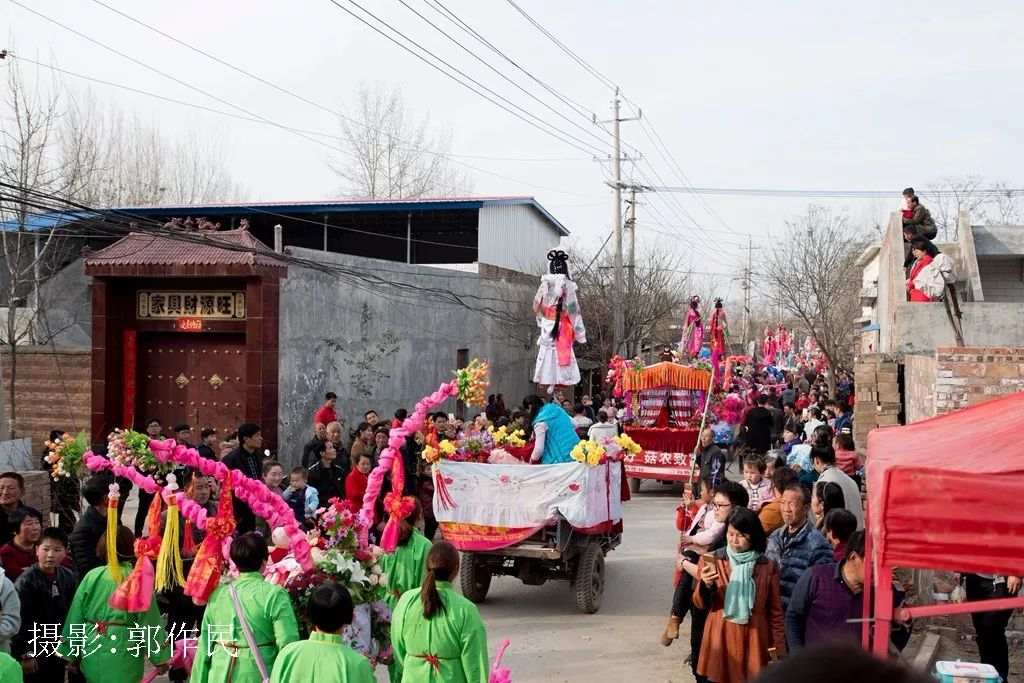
top-left (935, 347), bottom-right (1024, 415)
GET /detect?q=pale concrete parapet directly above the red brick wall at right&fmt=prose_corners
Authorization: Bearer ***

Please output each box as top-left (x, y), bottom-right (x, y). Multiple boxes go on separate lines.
top-left (887, 301), bottom-right (1024, 353)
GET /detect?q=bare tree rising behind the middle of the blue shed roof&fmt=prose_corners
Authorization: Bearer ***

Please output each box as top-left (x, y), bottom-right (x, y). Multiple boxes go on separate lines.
top-left (329, 83), bottom-right (472, 199)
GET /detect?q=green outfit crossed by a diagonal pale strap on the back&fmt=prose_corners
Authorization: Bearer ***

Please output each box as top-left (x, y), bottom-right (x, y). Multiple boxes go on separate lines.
top-left (189, 571), bottom-right (299, 683)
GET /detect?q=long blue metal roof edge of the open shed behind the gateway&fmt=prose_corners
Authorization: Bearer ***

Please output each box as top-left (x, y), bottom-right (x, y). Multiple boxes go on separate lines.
top-left (0, 197), bottom-right (569, 237)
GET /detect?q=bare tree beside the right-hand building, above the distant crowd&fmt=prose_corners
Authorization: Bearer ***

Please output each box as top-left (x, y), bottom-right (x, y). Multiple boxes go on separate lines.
top-left (763, 206), bottom-right (864, 396)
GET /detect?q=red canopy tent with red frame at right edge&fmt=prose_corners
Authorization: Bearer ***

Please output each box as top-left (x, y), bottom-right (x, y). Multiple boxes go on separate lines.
top-left (863, 393), bottom-right (1024, 656)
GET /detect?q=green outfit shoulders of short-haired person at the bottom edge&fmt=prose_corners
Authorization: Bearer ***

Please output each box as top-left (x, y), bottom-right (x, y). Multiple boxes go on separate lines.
top-left (270, 631), bottom-right (377, 683)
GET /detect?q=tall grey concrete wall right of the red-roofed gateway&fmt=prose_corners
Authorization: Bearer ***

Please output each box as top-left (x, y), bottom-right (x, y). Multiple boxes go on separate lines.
top-left (279, 249), bottom-right (536, 464)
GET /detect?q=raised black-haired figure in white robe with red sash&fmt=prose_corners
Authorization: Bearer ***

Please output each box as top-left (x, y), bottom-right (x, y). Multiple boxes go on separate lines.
top-left (534, 250), bottom-right (587, 393)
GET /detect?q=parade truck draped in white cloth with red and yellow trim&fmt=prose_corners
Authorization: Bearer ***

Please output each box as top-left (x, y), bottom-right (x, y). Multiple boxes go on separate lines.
top-left (433, 459), bottom-right (623, 614)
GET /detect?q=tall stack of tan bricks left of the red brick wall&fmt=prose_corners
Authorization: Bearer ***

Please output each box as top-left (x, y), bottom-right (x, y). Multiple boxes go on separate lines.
top-left (853, 353), bottom-right (903, 453)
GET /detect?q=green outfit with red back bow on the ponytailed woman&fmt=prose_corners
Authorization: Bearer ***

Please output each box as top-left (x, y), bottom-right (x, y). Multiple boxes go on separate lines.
top-left (391, 581), bottom-right (490, 683)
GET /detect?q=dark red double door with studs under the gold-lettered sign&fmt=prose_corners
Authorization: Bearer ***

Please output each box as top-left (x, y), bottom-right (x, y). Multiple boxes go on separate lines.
top-left (138, 333), bottom-right (246, 440)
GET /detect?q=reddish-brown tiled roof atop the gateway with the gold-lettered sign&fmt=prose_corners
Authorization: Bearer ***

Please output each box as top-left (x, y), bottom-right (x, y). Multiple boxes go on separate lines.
top-left (85, 229), bottom-right (285, 268)
